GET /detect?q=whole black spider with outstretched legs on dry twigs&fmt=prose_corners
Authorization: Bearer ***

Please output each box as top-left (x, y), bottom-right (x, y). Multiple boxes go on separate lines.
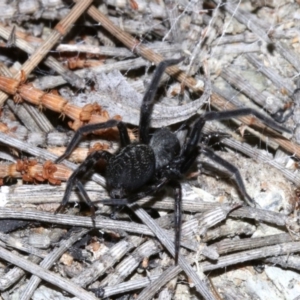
top-left (56, 58), bottom-right (289, 264)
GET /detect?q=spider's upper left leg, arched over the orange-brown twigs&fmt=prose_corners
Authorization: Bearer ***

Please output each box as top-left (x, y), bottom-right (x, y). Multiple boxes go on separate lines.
top-left (55, 120), bottom-right (130, 163)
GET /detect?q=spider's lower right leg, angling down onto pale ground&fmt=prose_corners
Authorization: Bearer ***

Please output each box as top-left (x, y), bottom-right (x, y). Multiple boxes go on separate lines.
top-left (200, 147), bottom-right (256, 207)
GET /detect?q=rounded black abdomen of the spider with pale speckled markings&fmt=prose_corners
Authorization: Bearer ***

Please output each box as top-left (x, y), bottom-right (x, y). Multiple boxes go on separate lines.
top-left (106, 144), bottom-right (155, 198)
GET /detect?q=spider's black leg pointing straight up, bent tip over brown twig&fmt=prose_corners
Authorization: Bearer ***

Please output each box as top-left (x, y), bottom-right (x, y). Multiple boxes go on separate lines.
top-left (139, 57), bottom-right (184, 144)
